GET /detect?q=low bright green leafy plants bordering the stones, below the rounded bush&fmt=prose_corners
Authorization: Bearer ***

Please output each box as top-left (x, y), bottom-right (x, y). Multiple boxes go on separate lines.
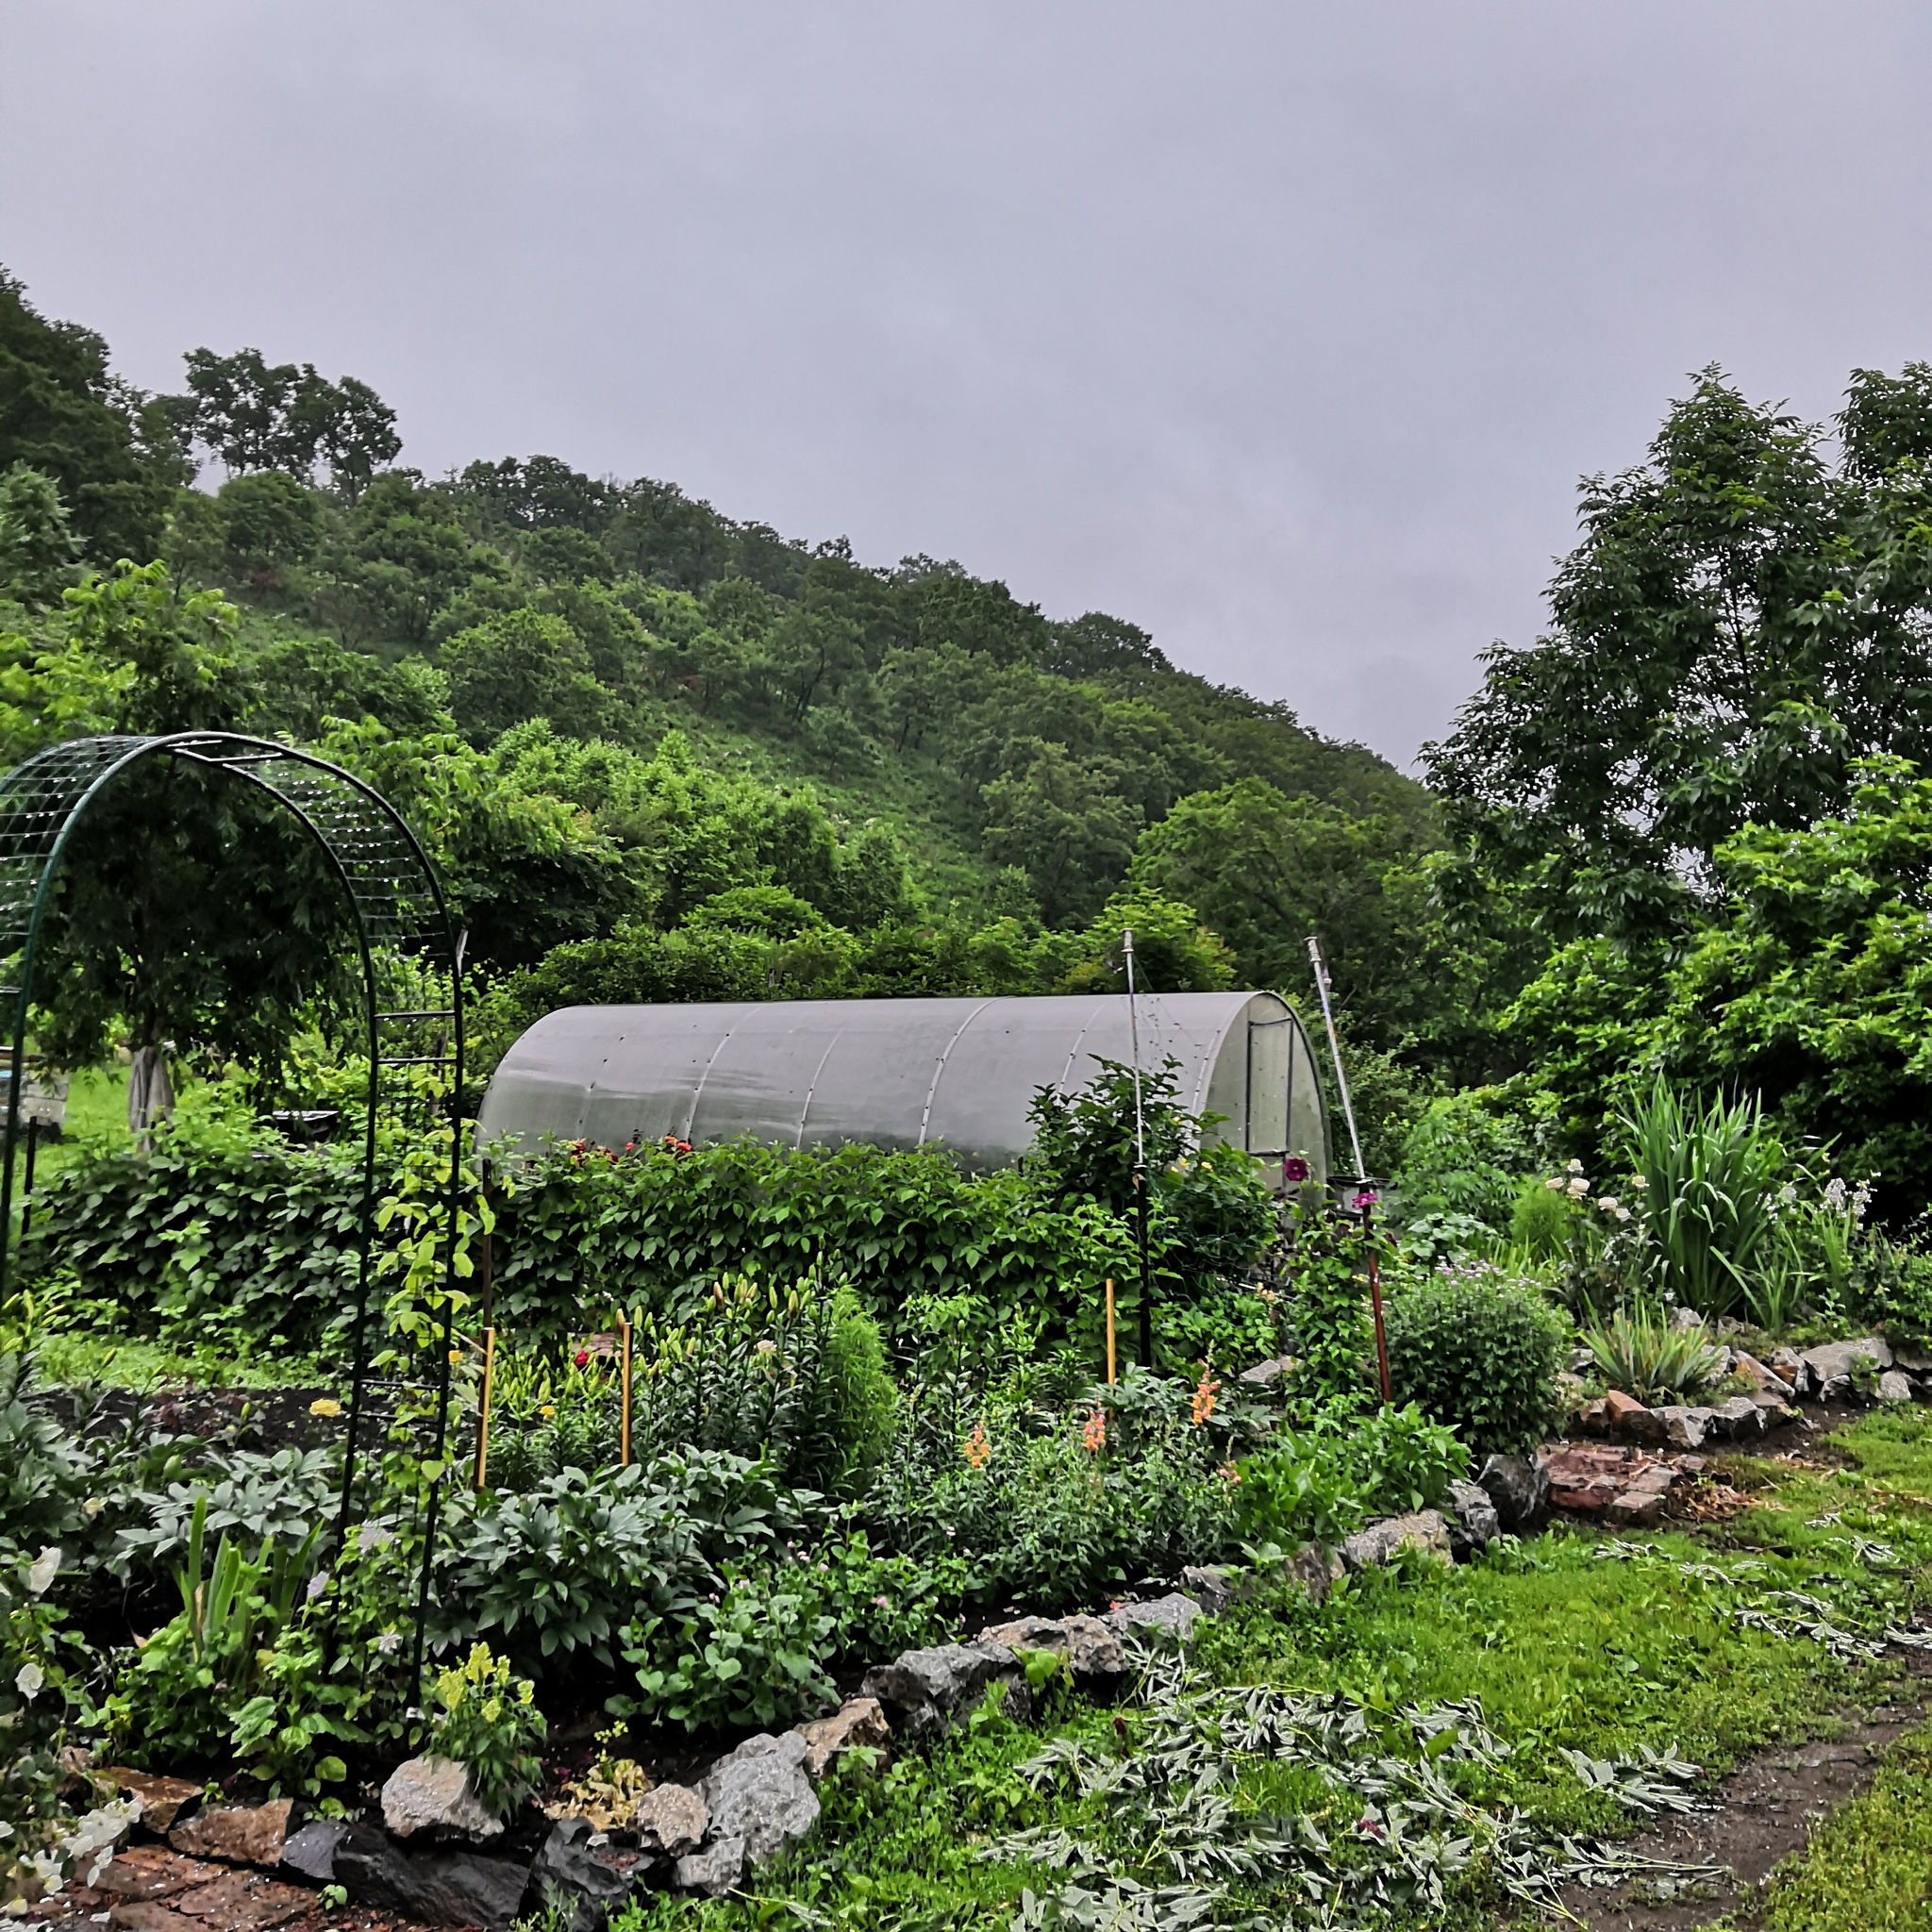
top-left (1235, 1403), bottom-right (1468, 1543)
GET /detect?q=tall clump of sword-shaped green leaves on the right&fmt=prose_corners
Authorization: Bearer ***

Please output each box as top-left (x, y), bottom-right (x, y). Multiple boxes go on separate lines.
top-left (1617, 1074), bottom-right (1785, 1320)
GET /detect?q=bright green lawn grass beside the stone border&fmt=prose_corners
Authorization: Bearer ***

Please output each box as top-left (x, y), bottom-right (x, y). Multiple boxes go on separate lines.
top-left (614, 1410), bottom-right (1932, 1932)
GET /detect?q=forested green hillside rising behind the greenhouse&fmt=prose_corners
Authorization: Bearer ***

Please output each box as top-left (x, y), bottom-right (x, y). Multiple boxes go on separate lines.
top-left (0, 264), bottom-right (1521, 1128)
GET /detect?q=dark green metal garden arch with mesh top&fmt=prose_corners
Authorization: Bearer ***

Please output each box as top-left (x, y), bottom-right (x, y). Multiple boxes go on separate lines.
top-left (0, 732), bottom-right (464, 1675)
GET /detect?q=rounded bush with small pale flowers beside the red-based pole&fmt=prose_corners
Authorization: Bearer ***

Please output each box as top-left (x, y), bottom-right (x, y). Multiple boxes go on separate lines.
top-left (1383, 1267), bottom-right (1569, 1455)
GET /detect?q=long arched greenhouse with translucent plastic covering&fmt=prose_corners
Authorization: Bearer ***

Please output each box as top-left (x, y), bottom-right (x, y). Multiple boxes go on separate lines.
top-left (481, 993), bottom-right (1327, 1182)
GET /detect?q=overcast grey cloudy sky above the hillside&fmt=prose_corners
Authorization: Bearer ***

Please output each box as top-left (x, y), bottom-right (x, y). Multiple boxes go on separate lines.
top-left (0, 0), bottom-right (1932, 761)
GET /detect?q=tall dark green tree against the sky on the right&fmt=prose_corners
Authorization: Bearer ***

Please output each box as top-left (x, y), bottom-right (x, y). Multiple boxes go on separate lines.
top-left (1424, 363), bottom-right (1932, 939)
